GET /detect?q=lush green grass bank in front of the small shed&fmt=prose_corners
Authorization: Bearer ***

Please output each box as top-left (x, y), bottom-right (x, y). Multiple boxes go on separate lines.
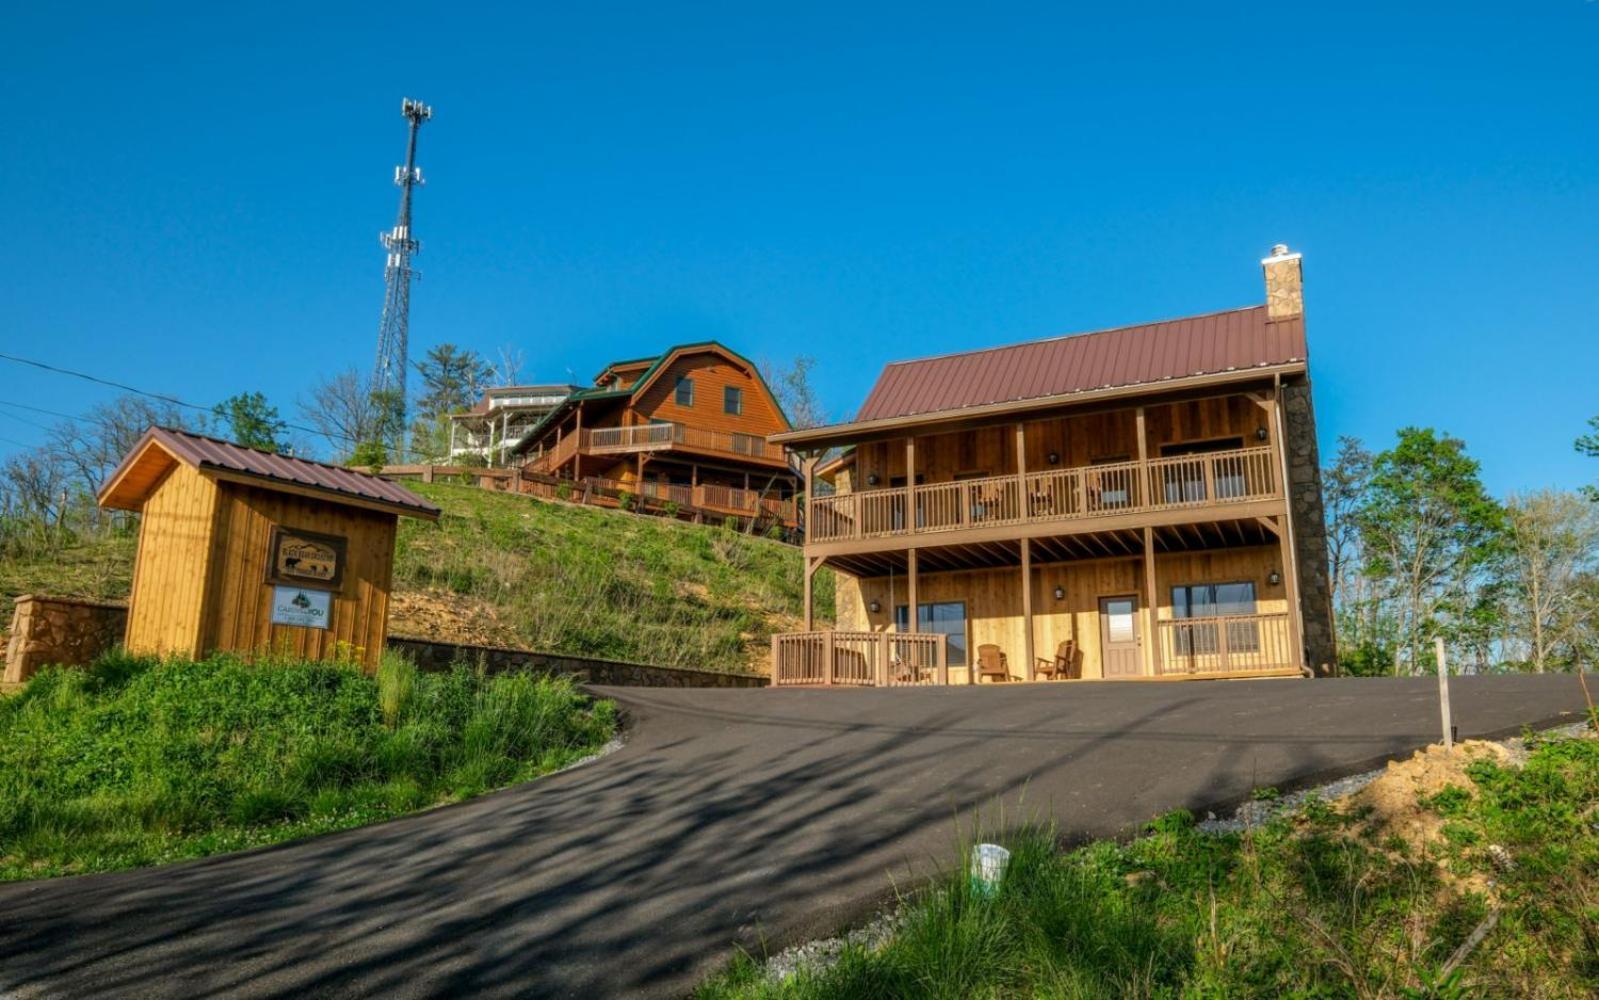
top-left (0, 654), bottom-right (616, 880)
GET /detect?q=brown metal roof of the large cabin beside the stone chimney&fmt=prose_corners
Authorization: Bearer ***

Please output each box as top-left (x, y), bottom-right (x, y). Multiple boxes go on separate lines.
top-left (855, 306), bottom-right (1306, 422)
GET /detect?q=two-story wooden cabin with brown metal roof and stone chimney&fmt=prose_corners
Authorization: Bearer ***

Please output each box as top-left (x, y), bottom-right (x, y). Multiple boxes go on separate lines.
top-left (772, 246), bottom-right (1334, 685)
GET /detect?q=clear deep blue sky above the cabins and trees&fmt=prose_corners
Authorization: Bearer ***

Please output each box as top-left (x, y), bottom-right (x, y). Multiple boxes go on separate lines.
top-left (0, 0), bottom-right (1599, 493)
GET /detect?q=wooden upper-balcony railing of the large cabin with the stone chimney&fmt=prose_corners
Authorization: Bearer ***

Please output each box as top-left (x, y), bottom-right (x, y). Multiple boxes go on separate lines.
top-left (809, 448), bottom-right (1282, 542)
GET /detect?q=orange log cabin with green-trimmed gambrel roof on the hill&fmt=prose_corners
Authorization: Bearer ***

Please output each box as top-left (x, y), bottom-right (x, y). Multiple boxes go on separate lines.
top-left (512, 341), bottom-right (798, 523)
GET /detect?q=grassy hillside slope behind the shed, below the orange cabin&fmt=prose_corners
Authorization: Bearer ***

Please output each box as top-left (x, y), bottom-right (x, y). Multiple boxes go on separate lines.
top-left (0, 483), bottom-right (833, 672)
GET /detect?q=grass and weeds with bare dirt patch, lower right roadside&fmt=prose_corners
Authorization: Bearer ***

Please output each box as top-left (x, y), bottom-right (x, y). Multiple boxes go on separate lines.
top-left (697, 729), bottom-right (1599, 1000)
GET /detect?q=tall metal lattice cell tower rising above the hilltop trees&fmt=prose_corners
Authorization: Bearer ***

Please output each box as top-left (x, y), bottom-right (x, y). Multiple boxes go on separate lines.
top-left (373, 98), bottom-right (433, 461)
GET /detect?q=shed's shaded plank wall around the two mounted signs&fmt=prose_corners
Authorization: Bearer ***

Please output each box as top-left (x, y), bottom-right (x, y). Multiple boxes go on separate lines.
top-left (203, 483), bottom-right (398, 669)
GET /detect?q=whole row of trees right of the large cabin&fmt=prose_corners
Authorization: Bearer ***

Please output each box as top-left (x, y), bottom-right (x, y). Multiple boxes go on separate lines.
top-left (1322, 418), bottom-right (1599, 675)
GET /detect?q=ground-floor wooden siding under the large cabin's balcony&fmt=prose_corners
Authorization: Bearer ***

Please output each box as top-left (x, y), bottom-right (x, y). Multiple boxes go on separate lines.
top-left (835, 546), bottom-right (1287, 683)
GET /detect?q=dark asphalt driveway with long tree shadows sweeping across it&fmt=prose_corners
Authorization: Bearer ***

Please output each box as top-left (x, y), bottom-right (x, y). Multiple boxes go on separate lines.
top-left (0, 677), bottom-right (1583, 998)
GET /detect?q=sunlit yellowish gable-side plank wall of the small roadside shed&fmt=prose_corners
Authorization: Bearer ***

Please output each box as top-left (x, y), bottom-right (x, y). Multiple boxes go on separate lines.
top-left (123, 462), bottom-right (217, 656)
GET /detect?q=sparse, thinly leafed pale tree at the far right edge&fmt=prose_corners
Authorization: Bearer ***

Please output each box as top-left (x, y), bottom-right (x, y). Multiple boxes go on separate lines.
top-left (1506, 490), bottom-right (1599, 674)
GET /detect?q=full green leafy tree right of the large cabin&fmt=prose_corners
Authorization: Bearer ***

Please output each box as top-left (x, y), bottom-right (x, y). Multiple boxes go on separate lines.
top-left (1358, 427), bottom-right (1503, 672)
